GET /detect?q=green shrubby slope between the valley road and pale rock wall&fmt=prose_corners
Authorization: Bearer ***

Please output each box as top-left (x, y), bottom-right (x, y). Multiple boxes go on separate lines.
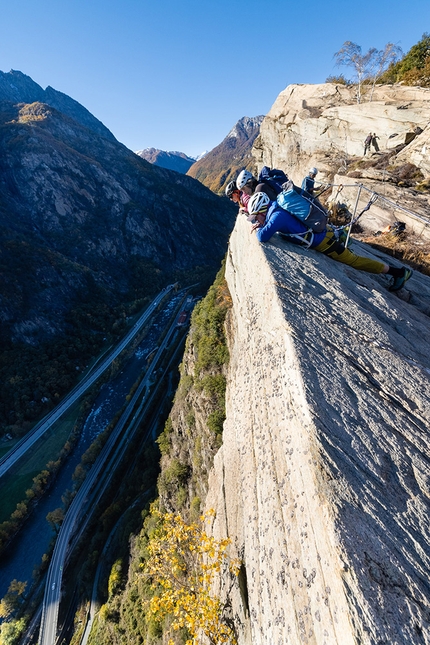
top-left (89, 262), bottom-right (231, 645)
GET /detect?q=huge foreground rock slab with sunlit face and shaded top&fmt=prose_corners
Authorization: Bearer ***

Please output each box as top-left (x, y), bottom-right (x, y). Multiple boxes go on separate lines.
top-left (206, 215), bottom-right (430, 645)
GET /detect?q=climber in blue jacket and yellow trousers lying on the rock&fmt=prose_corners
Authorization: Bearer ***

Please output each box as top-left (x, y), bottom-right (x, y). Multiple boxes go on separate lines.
top-left (247, 193), bottom-right (412, 291)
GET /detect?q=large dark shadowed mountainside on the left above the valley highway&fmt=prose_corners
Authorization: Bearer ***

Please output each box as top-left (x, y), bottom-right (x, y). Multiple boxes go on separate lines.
top-left (0, 74), bottom-right (235, 432)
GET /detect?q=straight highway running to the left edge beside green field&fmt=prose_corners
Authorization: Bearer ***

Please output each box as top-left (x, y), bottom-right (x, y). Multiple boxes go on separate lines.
top-left (0, 285), bottom-right (175, 478)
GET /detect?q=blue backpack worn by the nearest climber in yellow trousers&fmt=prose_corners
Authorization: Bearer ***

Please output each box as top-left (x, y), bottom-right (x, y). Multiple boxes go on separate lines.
top-left (277, 181), bottom-right (328, 233)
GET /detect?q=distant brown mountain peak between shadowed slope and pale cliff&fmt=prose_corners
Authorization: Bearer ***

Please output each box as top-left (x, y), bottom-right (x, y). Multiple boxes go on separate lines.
top-left (187, 116), bottom-right (264, 193)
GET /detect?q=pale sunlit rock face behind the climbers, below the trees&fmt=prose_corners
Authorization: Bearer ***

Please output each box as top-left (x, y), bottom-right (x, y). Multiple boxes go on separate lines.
top-left (253, 83), bottom-right (430, 237)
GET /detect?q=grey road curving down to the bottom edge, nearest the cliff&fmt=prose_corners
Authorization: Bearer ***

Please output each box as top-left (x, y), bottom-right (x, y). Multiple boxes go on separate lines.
top-left (39, 300), bottom-right (191, 645)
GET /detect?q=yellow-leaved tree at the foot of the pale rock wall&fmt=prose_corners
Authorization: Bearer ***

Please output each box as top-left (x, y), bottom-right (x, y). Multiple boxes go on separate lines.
top-left (141, 510), bottom-right (240, 645)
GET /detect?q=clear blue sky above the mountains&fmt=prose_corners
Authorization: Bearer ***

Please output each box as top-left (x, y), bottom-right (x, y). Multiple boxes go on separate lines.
top-left (0, 0), bottom-right (430, 156)
